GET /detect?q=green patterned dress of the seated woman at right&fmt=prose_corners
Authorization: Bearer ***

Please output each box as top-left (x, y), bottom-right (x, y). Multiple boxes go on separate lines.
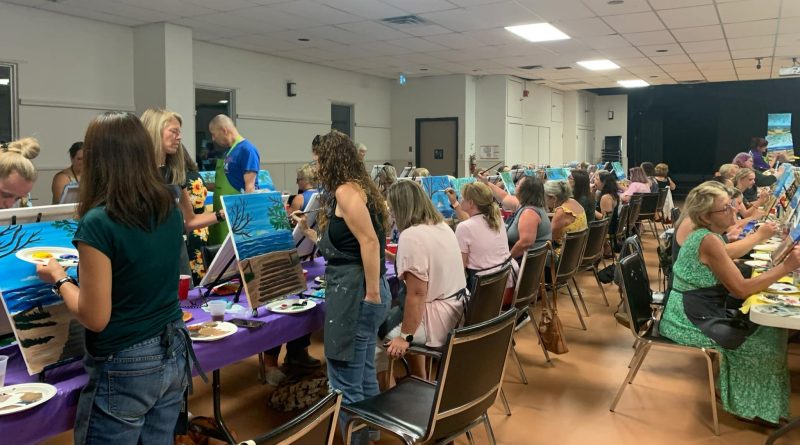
top-left (659, 229), bottom-right (790, 423)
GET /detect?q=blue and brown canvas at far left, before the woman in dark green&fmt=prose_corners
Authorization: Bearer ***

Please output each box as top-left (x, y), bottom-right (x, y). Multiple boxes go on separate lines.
top-left (0, 220), bottom-right (84, 375)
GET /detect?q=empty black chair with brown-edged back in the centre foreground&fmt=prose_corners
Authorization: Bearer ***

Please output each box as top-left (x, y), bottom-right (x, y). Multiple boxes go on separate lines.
top-left (342, 309), bottom-right (517, 445)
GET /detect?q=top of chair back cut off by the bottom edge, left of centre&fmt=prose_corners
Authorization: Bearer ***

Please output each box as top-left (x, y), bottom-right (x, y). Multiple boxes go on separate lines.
top-left (240, 391), bottom-right (342, 445)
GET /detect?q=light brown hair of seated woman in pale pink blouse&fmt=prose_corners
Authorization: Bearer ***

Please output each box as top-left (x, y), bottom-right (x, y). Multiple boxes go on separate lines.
top-left (388, 181), bottom-right (444, 232)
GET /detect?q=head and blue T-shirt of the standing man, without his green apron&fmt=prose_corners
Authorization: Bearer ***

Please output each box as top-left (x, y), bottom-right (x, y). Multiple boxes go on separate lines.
top-left (208, 114), bottom-right (261, 193)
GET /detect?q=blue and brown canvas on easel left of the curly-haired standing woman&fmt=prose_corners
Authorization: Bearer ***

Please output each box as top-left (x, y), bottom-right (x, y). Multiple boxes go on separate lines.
top-left (222, 192), bottom-right (306, 308)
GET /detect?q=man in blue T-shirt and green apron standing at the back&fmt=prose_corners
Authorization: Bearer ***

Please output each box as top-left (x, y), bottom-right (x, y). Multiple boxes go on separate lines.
top-left (208, 114), bottom-right (261, 245)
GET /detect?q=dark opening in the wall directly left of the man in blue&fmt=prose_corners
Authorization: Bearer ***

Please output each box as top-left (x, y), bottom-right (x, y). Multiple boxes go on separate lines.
top-left (194, 87), bottom-right (234, 171)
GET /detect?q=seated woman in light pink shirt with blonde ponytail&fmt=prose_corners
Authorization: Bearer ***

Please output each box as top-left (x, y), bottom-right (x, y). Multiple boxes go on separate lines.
top-left (455, 182), bottom-right (518, 305)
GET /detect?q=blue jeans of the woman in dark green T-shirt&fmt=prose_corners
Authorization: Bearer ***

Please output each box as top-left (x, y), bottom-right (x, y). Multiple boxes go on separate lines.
top-left (74, 320), bottom-right (191, 445)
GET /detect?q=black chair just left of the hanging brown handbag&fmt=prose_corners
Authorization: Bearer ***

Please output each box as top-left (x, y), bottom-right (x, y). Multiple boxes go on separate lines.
top-left (511, 243), bottom-right (552, 378)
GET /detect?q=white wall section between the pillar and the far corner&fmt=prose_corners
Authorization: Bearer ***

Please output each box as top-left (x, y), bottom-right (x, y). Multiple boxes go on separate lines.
top-left (194, 41), bottom-right (391, 191)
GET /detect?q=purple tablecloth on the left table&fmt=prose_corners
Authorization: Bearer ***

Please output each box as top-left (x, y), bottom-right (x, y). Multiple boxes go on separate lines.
top-left (0, 258), bottom-right (332, 444)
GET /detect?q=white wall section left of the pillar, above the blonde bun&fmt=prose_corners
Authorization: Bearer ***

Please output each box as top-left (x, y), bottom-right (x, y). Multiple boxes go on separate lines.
top-left (0, 3), bottom-right (134, 205)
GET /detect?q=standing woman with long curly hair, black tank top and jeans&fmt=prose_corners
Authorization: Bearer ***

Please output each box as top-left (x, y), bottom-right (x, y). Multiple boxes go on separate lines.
top-left (293, 130), bottom-right (391, 445)
